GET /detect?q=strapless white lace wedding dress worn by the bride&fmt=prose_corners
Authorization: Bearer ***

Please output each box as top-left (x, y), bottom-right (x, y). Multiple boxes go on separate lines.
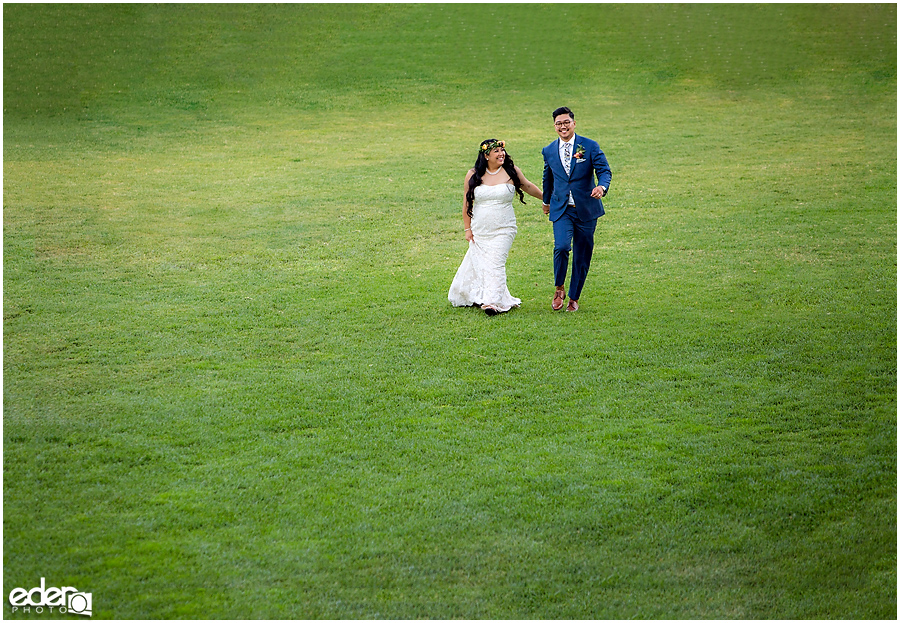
top-left (447, 184), bottom-right (522, 312)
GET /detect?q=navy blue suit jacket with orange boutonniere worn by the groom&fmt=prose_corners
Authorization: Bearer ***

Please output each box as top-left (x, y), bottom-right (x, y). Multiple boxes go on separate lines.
top-left (541, 134), bottom-right (612, 221)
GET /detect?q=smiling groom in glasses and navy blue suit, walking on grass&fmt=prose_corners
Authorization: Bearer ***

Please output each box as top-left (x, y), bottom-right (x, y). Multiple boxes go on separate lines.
top-left (541, 106), bottom-right (612, 311)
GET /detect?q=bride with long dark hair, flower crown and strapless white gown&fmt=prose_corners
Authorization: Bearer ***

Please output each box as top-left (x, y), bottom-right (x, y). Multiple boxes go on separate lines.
top-left (447, 138), bottom-right (543, 316)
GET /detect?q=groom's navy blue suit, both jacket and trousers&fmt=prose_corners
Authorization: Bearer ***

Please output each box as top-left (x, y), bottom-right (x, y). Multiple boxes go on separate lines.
top-left (541, 134), bottom-right (612, 301)
